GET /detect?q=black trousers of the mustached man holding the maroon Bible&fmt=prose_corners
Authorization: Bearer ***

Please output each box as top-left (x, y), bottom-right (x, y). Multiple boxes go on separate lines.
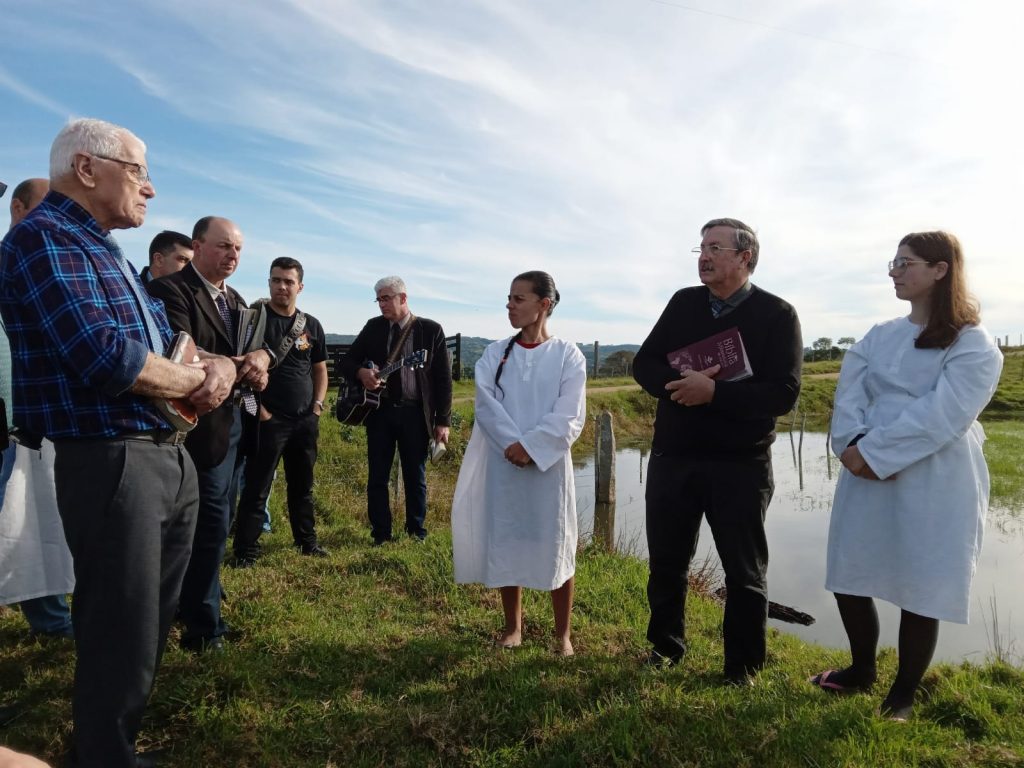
top-left (646, 454), bottom-right (774, 675)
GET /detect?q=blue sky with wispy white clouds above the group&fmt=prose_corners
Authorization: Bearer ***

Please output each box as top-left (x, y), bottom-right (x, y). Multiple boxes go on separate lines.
top-left (0, 0), bottom-right (1024, 344)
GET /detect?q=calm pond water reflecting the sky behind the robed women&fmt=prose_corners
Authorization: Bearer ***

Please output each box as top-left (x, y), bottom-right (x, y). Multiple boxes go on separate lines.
top-left (575, 432), bottom-right (1024, 662)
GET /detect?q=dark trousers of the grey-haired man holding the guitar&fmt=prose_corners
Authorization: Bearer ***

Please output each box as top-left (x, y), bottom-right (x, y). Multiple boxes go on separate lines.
top-left (367, 402), bottom-right (430, 541)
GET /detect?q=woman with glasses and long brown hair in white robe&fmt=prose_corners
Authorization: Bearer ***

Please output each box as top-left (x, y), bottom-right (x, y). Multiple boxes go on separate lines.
top-left (811, 231), bottom-right (1002, 720)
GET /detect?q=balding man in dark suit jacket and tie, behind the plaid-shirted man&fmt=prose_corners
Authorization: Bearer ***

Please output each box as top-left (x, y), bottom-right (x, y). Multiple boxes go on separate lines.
top-left (146, 216), bottom-right (272, 652)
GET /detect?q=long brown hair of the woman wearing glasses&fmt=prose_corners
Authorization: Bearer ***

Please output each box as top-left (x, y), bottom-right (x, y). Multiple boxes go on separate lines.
top-left (899, 231), bottom-right (981, 349)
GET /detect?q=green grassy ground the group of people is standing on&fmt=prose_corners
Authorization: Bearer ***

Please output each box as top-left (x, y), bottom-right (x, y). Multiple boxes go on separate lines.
top-left (0, 380), bottom-right (1024, 768)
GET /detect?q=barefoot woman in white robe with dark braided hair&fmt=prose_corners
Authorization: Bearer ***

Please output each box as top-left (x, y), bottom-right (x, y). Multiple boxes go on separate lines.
top-left (452, 271), bottom-right (587, 655)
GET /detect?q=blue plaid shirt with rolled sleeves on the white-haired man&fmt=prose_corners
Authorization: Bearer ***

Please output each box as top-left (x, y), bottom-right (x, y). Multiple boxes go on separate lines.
top-left (0, 191), bottom-right (171, 439)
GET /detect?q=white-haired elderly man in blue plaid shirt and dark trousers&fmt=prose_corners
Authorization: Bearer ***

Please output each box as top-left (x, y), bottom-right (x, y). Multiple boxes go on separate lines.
top-left (0, 120), bottom-right (237, 768)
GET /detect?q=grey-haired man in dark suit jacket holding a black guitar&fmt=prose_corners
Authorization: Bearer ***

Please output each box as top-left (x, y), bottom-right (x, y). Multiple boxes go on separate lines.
top-left (339, 276), bottom-right (452, 546)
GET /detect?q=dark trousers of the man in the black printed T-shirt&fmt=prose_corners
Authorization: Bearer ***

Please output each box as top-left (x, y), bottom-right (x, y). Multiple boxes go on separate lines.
top-left (234, 413), bottom-right (319, 558)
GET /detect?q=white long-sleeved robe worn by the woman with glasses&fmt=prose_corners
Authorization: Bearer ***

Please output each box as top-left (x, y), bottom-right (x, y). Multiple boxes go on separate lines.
top-left (825, 317), bottom-right (1002, 624)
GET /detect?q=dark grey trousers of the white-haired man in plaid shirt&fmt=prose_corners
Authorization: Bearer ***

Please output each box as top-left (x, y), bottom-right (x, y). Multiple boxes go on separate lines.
top-left (54, 439), bottom-right (199, 768)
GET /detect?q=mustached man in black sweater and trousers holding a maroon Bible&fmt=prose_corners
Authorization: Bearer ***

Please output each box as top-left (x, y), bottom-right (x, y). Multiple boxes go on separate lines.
top-left (634, 219), bottom-right (803, 684)
